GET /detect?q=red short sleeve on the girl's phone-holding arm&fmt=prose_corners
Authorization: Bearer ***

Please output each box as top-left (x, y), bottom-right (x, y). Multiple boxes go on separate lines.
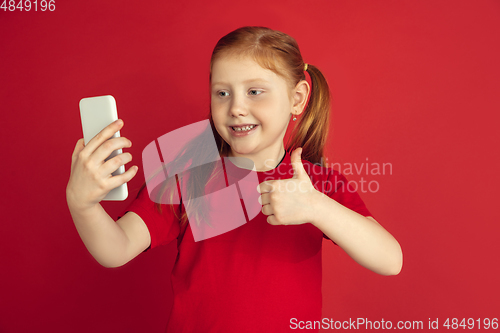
top-left (120, 187), bottom-right (180, 251)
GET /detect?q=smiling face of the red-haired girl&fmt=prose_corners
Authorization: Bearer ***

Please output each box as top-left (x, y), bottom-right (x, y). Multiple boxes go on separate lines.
top-left (211, 56), bottom-right (300, 170)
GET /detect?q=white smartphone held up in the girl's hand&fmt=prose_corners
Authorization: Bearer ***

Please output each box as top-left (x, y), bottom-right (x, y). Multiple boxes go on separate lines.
top-left (80, 95), bottom-right (128, 201)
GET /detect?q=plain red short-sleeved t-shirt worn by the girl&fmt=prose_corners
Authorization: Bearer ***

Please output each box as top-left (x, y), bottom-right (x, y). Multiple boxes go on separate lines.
top-left (124, 152), bottom-right (371, 332)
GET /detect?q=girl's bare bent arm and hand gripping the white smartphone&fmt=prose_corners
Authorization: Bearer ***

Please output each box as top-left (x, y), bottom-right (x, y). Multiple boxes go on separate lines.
top-left (66, 121), bottom-right (146, 267)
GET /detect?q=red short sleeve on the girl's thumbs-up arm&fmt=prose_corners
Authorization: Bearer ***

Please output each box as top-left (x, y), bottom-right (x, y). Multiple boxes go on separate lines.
top-left (323, 169), bottom-right (373, 244)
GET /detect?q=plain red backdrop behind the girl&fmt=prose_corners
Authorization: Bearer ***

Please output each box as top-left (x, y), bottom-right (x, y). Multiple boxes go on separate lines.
top-left (0, 0), bottom-right (500, 332)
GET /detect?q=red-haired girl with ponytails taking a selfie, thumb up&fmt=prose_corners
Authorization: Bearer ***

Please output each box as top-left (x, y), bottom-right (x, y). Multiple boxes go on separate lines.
top-left (66, 27), bottom-right (402, 332)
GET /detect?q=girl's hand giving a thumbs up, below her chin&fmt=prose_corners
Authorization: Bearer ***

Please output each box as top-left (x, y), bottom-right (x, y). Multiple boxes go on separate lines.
top-left (257, 148), bottom-right (322, 225)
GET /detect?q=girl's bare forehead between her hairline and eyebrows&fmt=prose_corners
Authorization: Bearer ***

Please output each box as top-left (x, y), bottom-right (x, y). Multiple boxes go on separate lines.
top-left (210, 55), bottom-right (283, 86)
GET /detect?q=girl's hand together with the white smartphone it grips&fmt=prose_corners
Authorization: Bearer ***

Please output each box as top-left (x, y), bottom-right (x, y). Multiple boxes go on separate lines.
top-left (66, 96), bottom-right (138, 209)
